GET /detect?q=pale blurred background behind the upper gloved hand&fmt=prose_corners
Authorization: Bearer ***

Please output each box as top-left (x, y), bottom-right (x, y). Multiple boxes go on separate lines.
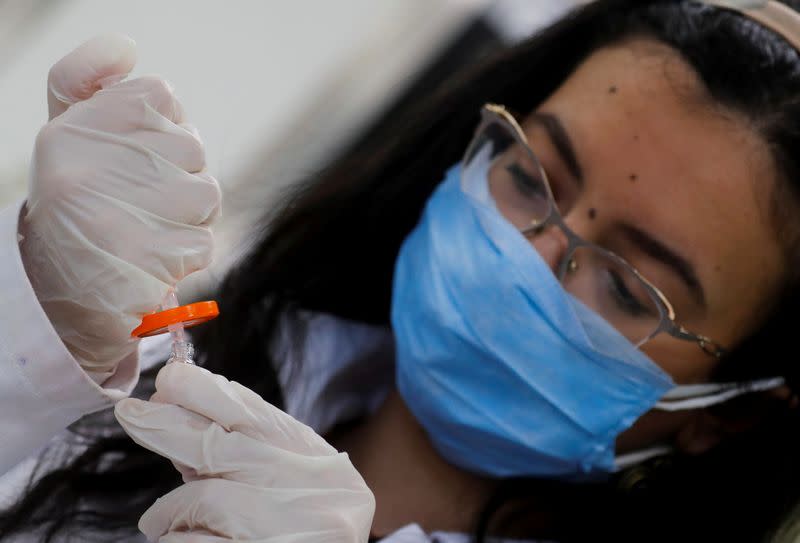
top-left (0, 0), bottom-right (585, 301)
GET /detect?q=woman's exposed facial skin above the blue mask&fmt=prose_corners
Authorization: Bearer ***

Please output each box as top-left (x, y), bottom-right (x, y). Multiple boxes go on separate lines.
top-left (490, 39), bottom-right (783, 446)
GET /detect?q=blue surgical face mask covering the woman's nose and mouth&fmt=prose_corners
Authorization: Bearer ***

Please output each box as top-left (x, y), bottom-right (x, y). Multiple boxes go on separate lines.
top-left (392, 166), bottom-right (775, 477)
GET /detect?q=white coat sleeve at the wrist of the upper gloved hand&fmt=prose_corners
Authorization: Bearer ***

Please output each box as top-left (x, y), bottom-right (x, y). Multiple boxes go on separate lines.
top-left (0, 202), bottom-right (139, 473)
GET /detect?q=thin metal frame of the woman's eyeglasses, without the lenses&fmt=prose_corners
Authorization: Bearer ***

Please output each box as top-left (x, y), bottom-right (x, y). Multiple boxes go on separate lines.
top-left (464, 103), bottom-right (726, 359)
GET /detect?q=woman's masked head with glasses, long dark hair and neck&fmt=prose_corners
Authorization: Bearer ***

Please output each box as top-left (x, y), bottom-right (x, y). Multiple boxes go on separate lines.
top-left (3, 0), bottom-right (800, 541)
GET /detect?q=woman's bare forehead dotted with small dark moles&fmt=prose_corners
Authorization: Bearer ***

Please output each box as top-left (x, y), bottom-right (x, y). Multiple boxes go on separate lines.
top-left (532, 39), bottom-right (782, 340)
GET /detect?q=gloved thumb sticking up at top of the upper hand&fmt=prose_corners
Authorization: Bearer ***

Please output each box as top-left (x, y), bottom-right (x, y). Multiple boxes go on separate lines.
top-left (47, 34), bottom-right (136, 120)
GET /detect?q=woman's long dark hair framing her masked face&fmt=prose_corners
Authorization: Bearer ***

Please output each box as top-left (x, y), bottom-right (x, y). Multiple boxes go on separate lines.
top-left (0, 0), bottom-right (800, 541)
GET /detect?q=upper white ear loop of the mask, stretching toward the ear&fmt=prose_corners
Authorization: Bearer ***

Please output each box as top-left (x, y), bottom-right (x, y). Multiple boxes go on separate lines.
top-left (653, 377), bottom-right (786, 411)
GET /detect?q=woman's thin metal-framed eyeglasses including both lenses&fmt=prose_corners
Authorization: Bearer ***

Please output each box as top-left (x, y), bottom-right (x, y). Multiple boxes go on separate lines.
top-left (461, 104), bottom-right (725, 358)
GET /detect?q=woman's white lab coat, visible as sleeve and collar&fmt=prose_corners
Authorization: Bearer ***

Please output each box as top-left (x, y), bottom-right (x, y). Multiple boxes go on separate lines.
top-left (0, 202), bottom-right (536, 543)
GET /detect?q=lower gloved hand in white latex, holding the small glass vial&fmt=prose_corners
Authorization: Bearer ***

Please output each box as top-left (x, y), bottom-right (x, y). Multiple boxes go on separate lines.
top-left (115, 363), bottom-right (375, 543)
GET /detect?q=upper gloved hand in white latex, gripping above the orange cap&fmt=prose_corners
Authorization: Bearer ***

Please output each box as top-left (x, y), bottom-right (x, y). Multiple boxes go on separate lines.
top-left (20, 35), bottom-right (220, 382)
